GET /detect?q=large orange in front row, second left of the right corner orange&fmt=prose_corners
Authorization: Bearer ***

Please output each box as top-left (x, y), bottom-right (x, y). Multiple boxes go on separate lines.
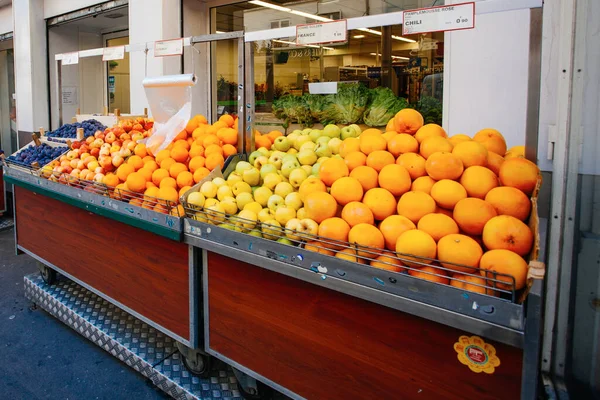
top-left (396, 229), bottom-right (437, 268)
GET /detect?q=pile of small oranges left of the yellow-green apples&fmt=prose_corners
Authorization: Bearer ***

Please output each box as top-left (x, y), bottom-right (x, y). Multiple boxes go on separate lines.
top-left (103, 115), bottom-right (238, 216)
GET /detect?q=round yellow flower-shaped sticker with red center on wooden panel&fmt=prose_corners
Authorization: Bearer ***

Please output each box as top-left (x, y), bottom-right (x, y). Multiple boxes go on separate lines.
top-left (454, 336), bottom-right (500, 374)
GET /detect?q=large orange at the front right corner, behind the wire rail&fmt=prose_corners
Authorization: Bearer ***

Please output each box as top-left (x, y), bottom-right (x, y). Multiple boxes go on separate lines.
top-left (479, 249), bottom-right (527, 290)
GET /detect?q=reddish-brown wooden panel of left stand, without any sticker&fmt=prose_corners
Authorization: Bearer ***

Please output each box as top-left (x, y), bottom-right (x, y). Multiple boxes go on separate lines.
top-left (14, 185), bottom-right (190, 339)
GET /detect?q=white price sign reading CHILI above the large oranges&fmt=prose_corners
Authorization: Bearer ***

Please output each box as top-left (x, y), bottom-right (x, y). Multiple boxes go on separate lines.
top-left (402, 2), bottom-right (475, 35)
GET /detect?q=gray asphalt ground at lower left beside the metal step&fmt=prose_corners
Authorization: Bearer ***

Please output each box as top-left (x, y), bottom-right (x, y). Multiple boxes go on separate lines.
top-left (0, 223), bottom-right (168, 400)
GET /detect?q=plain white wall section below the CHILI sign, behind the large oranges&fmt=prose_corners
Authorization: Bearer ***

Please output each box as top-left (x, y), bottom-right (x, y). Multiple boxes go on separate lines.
top-left (444, 6), bottom-right (530, 147)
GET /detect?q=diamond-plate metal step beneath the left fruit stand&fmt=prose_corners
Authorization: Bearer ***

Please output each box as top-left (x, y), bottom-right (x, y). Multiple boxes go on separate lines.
top-left (23, 274), bottom-right (241, 400)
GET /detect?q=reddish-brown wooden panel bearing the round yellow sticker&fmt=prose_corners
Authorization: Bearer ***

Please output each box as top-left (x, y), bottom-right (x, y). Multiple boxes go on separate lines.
top-left (208, 253), bottom-right (522, 400)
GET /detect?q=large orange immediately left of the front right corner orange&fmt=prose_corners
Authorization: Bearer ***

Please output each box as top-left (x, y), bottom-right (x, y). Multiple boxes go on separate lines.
top-left (438, 233), bottom-right (483, 274)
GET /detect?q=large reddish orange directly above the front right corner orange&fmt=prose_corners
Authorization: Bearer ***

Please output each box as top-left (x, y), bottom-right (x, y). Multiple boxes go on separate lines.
top-left (482, 215), bottom-right (533, 256)
